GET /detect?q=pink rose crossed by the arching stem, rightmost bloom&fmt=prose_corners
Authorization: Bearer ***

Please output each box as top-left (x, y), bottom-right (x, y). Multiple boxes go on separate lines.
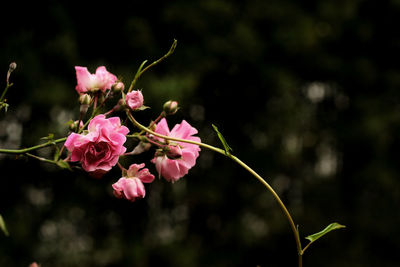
top-left (151, 118), bottom-right (201, 182)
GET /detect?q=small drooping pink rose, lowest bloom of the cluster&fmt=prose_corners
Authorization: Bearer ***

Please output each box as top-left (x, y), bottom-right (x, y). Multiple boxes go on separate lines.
top-left (112, 163), bottom-right (154, 202)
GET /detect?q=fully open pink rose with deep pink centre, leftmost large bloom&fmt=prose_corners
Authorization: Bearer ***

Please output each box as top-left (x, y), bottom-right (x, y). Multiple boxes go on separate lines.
top-left (65, 115), bottom-right (129, 177)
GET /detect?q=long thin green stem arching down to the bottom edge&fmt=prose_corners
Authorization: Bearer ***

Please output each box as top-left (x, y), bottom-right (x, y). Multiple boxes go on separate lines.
top-left (126, 111), bottom-right (303, 267)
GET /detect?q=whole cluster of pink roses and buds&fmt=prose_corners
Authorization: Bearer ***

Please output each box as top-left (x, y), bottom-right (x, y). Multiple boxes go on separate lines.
top-left (64, 66), bottom-right (201, 201)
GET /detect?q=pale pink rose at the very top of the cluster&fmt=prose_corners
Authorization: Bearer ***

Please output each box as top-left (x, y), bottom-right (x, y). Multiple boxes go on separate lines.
top-left (75, 66), bottom-right (117, 94)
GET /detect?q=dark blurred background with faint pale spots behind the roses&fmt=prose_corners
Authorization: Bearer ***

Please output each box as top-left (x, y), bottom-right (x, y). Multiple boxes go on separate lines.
top-left (0, 0), bottom-right (400, 267)
